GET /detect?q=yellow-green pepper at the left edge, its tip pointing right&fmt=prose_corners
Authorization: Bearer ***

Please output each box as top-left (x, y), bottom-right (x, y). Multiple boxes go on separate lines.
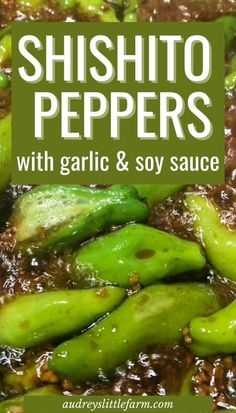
top-left (0, 287), bottom-right (125, 348)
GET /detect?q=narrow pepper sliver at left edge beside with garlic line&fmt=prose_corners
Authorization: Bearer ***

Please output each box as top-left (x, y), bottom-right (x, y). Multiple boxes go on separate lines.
top-left (0, 115), bottom-right (11, 191)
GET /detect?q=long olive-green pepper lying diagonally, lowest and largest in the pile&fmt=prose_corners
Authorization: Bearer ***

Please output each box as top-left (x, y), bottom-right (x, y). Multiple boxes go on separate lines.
top-left (49, 283), bottom-right (220, 383)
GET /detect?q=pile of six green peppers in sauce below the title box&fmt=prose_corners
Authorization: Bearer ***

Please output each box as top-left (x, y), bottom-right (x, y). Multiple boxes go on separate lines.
top-left (0, 180), bottom-right (236, 390)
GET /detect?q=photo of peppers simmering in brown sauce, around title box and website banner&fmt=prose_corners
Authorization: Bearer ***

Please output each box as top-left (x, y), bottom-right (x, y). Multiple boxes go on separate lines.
top-left (0, 0), bottom-right (236, 413)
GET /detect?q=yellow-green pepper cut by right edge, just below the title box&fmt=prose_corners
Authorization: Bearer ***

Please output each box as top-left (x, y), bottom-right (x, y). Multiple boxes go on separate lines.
top-left (186, 195), bottom-right (236, 281)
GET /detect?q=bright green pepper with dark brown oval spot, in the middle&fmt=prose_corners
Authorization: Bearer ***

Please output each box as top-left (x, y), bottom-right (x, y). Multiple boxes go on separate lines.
top-left (72, 224), bottom-right (206, 287)
